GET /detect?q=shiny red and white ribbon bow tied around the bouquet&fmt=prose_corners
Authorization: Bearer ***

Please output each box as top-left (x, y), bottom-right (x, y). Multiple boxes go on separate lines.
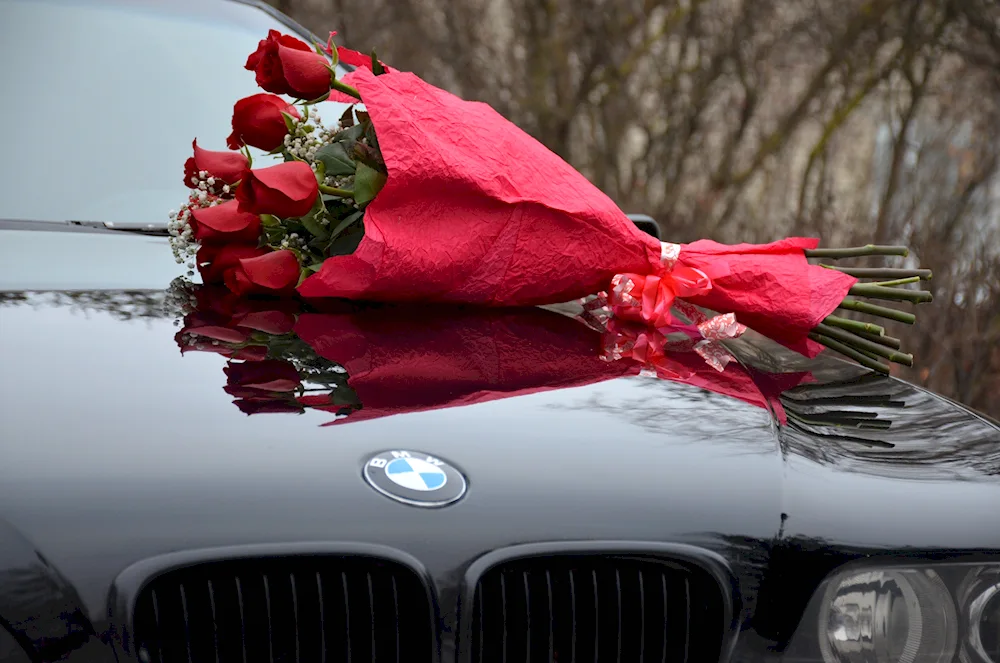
top-left (596, 242), bottom-right (747, 372)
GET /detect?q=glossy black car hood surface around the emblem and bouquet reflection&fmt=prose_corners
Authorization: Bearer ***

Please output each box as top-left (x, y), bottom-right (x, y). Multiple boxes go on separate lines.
top-left (0, 230), bottom-right (1000, 652)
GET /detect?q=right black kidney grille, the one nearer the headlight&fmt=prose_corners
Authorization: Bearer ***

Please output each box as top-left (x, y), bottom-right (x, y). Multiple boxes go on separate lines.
top-left (471, 556), bottom-right (726, 663)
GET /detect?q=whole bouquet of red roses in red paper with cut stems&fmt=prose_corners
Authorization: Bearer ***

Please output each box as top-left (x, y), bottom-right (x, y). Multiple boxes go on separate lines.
top-left (170, 31), bottom-right (930, 372)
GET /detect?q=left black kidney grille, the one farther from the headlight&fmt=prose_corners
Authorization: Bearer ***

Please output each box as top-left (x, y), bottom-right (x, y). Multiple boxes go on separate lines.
top-left (134, 557), bottom-right (434, 663)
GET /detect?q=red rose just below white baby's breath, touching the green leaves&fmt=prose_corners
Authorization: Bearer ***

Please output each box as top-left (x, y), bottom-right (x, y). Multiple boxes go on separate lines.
top-left (236, 161), bottom-right (319, 219)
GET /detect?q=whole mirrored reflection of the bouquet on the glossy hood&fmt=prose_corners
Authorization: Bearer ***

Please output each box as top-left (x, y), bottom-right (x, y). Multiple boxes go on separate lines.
top-left (175, 286), bottom-right (809, 423)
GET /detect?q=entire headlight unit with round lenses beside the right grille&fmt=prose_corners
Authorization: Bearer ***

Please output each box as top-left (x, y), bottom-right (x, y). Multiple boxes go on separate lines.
top-left (787, 563), bottom-right (1000, 663)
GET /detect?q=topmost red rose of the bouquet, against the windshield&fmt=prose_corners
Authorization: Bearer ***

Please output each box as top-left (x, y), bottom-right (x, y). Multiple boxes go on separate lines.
top-left (246, 30), bottom-right (331, 100)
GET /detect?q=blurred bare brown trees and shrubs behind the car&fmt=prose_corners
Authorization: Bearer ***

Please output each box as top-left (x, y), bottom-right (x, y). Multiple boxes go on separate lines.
top-left (269, 0), bottom-right (1000, 417)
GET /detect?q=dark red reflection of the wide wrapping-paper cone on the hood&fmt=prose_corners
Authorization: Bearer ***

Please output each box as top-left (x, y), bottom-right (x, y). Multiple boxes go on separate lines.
top-left (295, 309), bottom-right (639, 423)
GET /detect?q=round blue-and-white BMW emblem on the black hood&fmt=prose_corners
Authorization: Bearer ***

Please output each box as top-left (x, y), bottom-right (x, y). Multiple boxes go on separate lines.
top-left (364, 450), bottom-right (466, 507)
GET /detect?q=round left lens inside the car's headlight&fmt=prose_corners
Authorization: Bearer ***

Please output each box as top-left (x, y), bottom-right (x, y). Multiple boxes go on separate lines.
top-left (818, 569), bottom-right (958, 663)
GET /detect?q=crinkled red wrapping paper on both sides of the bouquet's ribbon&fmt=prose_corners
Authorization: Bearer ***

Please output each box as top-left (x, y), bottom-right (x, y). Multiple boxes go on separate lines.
top-left (299, 67), bottom-right (855, 356)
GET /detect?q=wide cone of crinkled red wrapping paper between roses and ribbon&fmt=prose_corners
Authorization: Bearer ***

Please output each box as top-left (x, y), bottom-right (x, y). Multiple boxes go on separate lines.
top-left (299, 68), bottom-right (660, 306)
